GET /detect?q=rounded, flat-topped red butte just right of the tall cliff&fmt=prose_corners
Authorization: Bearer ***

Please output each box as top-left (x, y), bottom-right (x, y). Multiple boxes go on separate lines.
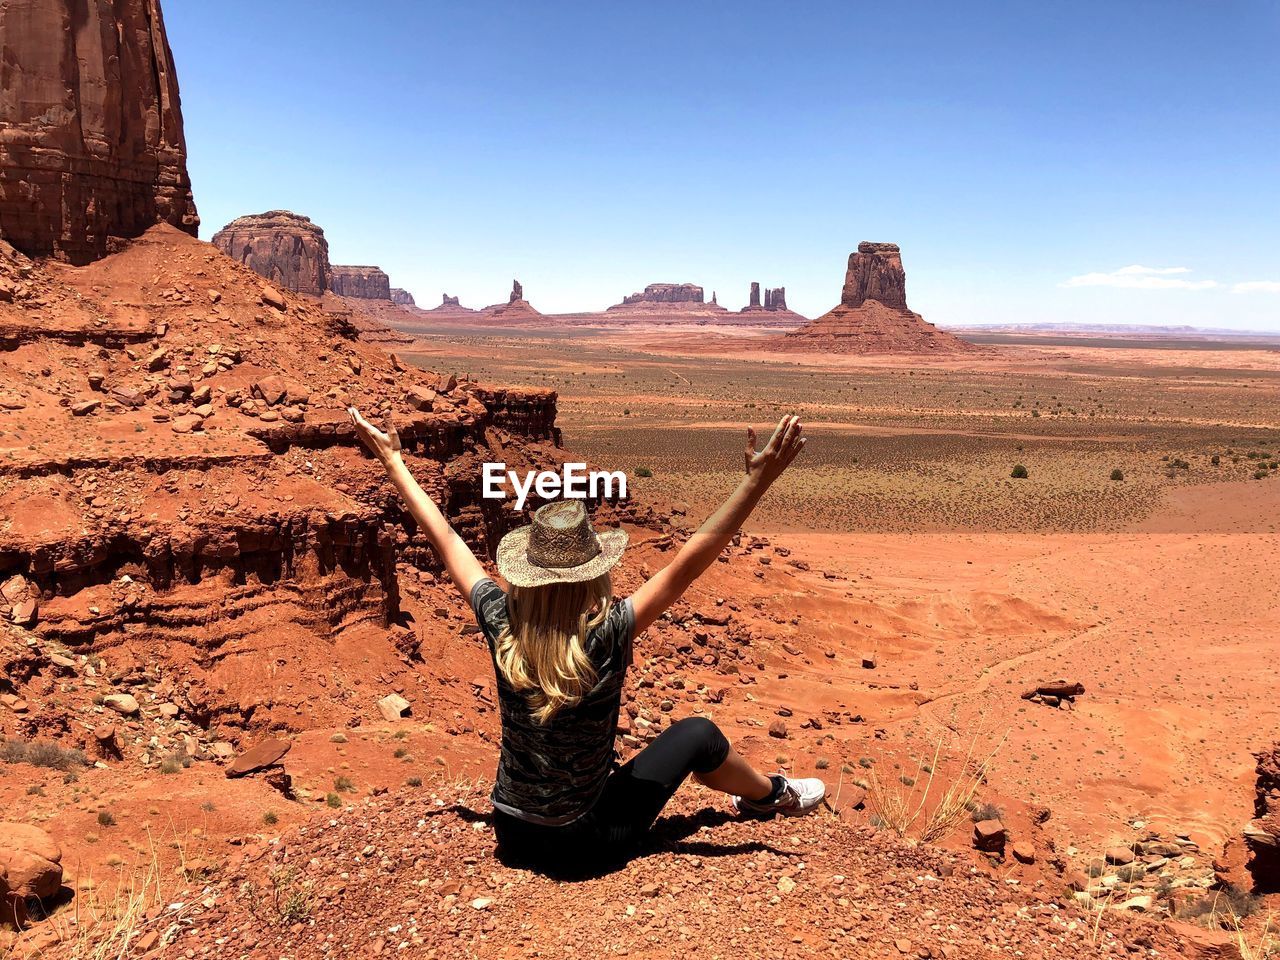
top-left (212, 210), bottom-right (330, 297)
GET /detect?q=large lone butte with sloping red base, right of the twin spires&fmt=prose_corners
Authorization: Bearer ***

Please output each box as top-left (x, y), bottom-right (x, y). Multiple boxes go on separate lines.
top-left (771, 242), bottom-right (980, 353)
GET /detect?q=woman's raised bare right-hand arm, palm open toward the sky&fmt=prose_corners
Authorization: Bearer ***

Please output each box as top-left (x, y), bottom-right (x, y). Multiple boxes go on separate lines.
top-left (631, 416), bottom-right (804, 634)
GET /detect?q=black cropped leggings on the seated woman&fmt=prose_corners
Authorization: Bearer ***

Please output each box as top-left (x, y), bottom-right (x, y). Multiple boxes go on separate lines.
top-left (493, 717), bottom-right (730, 873)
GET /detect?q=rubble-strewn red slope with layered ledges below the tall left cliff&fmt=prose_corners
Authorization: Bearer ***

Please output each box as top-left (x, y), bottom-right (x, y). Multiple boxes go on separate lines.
top-left (0, 225), bottom-right (561, 742)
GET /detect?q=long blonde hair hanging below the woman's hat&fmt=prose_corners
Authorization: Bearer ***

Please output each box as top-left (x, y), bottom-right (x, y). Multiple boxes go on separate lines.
top-left (494, 573), bottom-right (613, 724)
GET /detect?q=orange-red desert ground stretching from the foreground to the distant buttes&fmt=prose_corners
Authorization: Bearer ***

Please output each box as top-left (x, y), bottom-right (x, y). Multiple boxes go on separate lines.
top-left (0, 299), bottom-right (1280, 957)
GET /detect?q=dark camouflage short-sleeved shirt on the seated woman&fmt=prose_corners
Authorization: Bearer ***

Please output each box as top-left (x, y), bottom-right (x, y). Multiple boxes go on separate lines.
top-left (471, 579), bottom-right (636, 826)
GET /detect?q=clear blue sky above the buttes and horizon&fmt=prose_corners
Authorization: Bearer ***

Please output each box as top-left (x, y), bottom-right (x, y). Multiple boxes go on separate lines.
top-left (165, 0), bottom-right (1280, 330)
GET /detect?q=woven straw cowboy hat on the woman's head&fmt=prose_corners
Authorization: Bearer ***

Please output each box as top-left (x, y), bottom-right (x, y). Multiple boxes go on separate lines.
top-left (498, 500), bottom-right (627, 586)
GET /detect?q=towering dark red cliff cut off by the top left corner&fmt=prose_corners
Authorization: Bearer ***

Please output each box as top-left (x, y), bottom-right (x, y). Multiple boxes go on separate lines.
top-left (0, 0), bottom-right (200, 264)
